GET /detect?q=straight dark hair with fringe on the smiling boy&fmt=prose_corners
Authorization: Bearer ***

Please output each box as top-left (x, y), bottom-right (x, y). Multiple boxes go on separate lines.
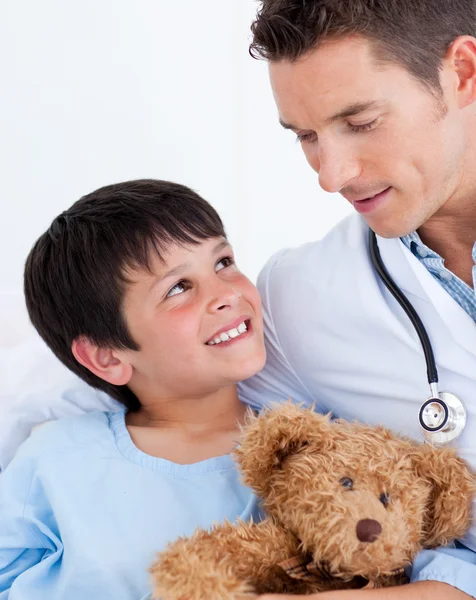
top-left (24, 179), bottom-right (226, 410)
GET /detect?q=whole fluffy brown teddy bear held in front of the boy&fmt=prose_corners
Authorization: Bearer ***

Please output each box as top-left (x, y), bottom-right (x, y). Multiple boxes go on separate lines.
top-left (151, 402), bottom-right (476, 600)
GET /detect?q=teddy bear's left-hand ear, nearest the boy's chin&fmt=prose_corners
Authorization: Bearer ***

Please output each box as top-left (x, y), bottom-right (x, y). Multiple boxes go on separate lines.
top-left (236, 400), bottom-right (333, 496)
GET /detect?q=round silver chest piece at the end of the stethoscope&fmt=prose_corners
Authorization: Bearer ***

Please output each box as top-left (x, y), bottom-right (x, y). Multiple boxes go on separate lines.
top-left (419, 392), bottom-right (466, 446)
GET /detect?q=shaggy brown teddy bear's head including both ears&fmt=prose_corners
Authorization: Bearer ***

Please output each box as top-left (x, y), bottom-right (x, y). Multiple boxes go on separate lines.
top-left (237, 402), bottom-right (475, 579)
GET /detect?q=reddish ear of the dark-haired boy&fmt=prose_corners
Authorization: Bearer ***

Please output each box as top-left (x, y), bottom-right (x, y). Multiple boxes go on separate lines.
top-left (71, 337), bottom-right (133, 385)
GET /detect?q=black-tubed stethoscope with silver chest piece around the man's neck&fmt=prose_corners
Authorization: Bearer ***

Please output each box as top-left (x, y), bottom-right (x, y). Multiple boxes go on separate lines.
top-left (369, 229), bottom-right (466, 446)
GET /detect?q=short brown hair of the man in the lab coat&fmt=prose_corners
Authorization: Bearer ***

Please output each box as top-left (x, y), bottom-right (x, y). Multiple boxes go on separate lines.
top-left (250, 0), bottom-right (476, 96)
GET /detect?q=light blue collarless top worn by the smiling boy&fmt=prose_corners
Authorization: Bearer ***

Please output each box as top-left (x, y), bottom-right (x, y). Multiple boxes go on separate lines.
top-left (0, 411), bottom-right (260, 600)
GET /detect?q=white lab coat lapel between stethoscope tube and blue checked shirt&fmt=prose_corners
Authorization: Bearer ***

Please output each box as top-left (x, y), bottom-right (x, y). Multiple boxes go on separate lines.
top-left (377, 236), bottom-right (476, 356)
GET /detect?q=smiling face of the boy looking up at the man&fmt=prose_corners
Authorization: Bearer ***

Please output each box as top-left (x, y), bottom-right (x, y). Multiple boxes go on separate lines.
top-left (115, 238), bottom-right (266, 402)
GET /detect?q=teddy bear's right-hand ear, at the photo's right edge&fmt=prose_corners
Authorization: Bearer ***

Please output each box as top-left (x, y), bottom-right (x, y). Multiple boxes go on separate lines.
top-left (411, 444), bottom-right (476, 548)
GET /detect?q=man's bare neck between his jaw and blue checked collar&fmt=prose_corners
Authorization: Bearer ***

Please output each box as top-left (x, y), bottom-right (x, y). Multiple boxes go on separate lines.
top-left (418, 199), bottom-right (476, 287)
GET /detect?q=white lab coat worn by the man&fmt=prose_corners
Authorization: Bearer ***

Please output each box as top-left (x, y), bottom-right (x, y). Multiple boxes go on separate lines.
top-left (240, 215), bottom-right (476, 551)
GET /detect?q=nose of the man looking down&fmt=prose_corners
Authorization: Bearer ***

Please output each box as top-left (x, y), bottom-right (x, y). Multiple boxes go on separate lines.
top-left (309, 142), bottom-right (361, 193)
